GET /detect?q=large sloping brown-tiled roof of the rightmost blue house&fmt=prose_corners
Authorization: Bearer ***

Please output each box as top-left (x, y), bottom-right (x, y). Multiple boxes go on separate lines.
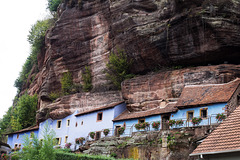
top-left (177, 78), bottom-right (240, 108)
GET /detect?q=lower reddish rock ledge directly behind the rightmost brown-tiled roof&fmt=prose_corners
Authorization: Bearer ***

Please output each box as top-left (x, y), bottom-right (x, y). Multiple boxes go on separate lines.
top-left (122, 64), bottom-right (240, 111)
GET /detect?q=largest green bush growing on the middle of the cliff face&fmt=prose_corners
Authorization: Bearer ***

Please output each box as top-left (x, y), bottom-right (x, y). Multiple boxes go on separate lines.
top-left (106, 49), bottom-right (134, 89)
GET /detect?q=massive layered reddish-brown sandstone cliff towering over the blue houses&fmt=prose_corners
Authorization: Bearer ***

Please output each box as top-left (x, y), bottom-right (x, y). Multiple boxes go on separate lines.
top-left (21, 0), bottom-right (240, 120)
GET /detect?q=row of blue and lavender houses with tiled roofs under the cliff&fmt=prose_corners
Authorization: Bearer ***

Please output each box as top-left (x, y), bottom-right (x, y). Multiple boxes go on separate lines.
top-left (8, 78), bottom-right (240, 154)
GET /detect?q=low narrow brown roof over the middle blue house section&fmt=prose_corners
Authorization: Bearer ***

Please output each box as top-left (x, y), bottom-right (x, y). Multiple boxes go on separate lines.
top-left (113, 103), bottom-right (177, 121)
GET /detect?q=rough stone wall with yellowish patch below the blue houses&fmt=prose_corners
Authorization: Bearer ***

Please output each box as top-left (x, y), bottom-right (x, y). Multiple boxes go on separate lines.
top-left (84, 126), bottom-right (216, 160)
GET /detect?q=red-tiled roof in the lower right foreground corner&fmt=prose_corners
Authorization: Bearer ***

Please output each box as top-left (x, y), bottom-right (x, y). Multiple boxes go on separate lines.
top-left (190, 106), bottom-right (240, 156)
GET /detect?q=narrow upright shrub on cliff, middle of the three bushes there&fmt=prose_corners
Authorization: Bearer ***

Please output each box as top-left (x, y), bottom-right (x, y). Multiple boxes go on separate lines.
top-left (82, 66), bottom-right (92, 92)
